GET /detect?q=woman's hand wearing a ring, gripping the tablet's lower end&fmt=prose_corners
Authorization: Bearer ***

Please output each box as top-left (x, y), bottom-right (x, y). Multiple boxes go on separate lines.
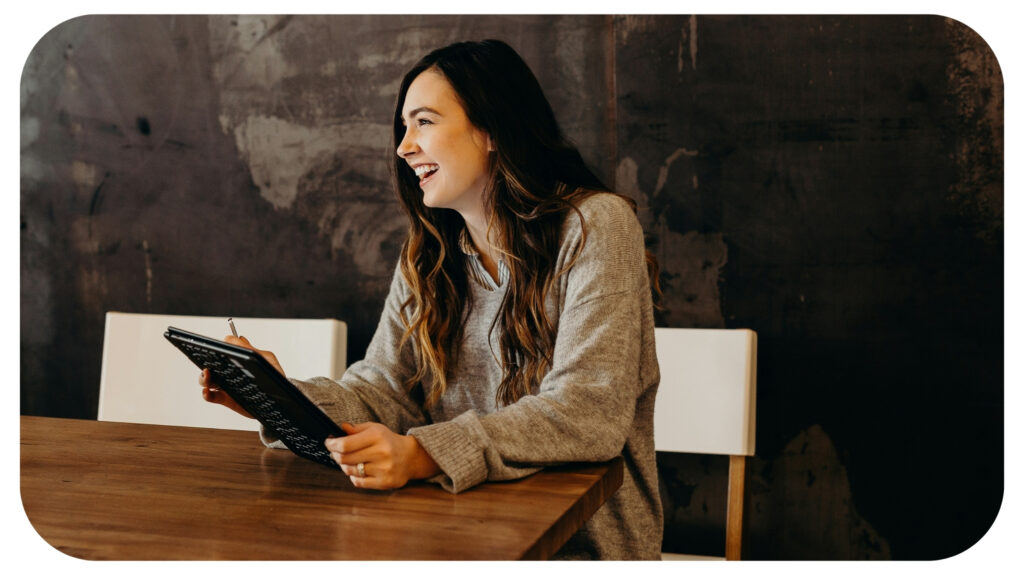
top-left (324, 423), bottom-right (440, 489)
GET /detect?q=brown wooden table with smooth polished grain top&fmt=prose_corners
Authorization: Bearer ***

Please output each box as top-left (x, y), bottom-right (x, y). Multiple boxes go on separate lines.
top-left (22, 415), bottom-right (623, 560)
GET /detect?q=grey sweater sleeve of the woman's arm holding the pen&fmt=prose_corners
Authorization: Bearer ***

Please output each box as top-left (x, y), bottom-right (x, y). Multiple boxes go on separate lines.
top-left (260, 261), bottom-right (429, 447)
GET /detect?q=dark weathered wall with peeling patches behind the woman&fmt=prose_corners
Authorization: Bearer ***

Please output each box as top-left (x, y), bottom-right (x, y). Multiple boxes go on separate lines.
top-left (20, 16), bottom-right (1002, 559)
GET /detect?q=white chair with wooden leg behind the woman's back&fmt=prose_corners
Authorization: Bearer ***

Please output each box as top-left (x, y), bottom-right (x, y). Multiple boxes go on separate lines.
top-left (654, 327), bottom-right (758, 560)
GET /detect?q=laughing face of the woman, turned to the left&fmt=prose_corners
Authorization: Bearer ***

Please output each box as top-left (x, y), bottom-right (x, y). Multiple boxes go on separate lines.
top-left (396, 70), bottom-right (494, 217)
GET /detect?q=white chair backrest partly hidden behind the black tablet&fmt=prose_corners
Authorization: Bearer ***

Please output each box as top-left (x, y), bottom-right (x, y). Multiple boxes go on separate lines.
top-left (97, 312), bottom-right (347, 430)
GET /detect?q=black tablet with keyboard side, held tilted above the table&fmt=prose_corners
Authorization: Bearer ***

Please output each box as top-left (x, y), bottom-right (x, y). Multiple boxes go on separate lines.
top-left (164, 326), bottom-right (345, 468)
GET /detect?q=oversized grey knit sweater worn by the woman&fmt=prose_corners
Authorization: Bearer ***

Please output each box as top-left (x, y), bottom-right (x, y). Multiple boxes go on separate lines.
top-left (261, 193), bottom-right (662, 560)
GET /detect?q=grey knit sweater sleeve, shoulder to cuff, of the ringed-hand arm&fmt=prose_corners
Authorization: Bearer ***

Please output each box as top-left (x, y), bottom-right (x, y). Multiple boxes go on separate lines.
top-left (410, 194), bottom-right (656, 492)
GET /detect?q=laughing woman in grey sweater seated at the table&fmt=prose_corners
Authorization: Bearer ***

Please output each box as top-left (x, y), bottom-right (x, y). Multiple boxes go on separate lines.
top-left (201, 40), bottom-right (662, 559)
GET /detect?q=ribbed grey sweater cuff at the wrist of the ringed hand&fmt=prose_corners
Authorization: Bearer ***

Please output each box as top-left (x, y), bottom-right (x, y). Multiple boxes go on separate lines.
top-left (409, 411), bottom-right (487, 493)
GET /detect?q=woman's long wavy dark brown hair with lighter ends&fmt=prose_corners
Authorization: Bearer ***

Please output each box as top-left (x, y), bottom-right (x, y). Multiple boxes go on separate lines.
top-left (392, 40), bottom-right (658, 405)
